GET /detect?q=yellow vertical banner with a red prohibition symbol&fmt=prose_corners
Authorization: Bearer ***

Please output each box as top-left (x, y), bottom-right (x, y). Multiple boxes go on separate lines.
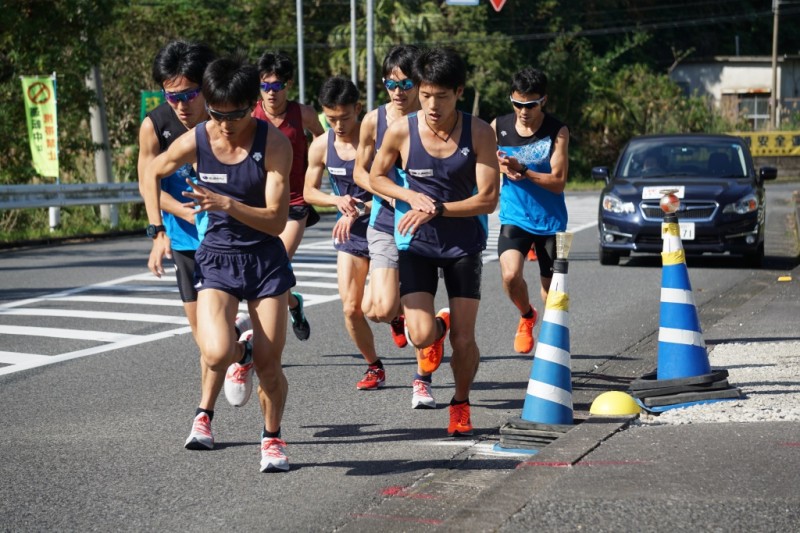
top-left (20, 73), bottom-right (58, 181)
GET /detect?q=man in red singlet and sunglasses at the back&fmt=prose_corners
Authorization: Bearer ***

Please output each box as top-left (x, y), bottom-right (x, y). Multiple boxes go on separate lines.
top-left (253, 52), bottom-right (325, 341)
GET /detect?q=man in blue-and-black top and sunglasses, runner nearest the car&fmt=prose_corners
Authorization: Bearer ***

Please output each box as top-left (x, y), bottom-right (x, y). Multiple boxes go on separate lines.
top-left (492, 67), bottom-right (569, 353)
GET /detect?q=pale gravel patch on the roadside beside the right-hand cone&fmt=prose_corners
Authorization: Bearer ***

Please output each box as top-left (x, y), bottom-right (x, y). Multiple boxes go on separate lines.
top-left (634, 341), bottom-right (800, 426)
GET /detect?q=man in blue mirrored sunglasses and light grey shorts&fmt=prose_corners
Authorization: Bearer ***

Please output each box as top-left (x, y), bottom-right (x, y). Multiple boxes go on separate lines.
top-left (353, 45), bottom-right (419, 360)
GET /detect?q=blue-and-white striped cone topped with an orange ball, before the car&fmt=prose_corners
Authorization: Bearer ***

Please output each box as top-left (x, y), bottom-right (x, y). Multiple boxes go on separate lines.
top-left (656, 213), bottom-right (711, 380)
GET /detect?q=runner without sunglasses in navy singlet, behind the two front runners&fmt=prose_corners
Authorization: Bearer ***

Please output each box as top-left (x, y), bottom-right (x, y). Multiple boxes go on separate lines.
top-left (303, 76), bottom-right (386, 390)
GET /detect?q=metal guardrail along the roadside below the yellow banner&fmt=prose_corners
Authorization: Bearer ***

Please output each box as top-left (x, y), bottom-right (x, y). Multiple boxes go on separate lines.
top-left (0, 182), bottom-right (142, 209)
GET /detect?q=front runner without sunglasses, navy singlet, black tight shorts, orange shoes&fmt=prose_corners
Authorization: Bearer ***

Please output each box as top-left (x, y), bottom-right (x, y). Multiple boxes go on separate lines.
top-left (370, 49), bottom-right (499, 436)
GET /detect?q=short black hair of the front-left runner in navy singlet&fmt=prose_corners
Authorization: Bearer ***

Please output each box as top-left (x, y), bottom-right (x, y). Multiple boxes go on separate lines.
top-left (203, 52), bottom-right (261, 109)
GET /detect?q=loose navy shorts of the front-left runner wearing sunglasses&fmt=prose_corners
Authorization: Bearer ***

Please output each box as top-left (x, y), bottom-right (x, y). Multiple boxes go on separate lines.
top-left (195, 238), bottom-right (297, 301)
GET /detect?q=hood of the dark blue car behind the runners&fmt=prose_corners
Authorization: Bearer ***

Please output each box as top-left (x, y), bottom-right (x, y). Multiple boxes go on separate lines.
top-left (604, 176), bottom-right (754, 201)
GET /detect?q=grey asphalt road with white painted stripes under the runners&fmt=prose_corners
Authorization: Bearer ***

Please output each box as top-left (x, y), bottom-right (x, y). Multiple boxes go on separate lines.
top-left (0, 184), bottom-right (792, 531)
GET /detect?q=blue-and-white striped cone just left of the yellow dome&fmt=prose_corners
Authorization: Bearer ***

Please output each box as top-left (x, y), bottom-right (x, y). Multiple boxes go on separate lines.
top-left (521, 259), bottom-right (573, 424)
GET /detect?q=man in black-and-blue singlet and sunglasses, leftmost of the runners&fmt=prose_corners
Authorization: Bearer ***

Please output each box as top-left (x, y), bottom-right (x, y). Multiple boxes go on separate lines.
top-left (138, 41), bottom-right (250, 450)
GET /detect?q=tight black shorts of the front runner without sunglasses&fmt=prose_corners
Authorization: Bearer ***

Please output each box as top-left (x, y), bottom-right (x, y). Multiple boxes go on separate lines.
top-left (400, 250), bottom-right (483, 300)
